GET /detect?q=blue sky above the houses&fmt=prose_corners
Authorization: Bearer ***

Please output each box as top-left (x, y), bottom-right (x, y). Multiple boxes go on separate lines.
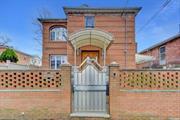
top-left (0, 0), bottom-right (180, 57)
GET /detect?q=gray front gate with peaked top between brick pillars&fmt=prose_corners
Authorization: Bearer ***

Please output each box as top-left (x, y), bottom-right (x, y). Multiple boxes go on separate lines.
top-left (73, 60), bottom-right (108, 113)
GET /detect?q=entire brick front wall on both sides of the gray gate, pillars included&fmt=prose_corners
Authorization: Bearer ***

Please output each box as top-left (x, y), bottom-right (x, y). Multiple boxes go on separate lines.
top-left (0, 65), bottom-right (180, 120)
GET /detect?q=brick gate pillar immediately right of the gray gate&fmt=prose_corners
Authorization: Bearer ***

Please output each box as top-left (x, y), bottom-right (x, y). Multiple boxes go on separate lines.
top-left (109, 63), bottom-right (120, 119)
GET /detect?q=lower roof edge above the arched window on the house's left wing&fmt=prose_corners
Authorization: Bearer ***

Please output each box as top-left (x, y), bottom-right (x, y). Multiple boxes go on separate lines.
top-left (38, 18), bottom-right (67, 23)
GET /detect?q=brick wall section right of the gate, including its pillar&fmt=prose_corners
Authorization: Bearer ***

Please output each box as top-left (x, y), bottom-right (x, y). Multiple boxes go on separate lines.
top-left (109, 65), bottom-right (180, 120)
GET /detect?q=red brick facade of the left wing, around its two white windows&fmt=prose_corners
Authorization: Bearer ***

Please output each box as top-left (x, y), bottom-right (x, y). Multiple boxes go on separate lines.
top-left (42, 20), bottom-right (68, 69)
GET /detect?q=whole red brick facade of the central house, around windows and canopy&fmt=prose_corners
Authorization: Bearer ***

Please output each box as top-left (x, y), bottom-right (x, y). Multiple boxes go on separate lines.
top-left (41, 6), bottom-right (139, 69)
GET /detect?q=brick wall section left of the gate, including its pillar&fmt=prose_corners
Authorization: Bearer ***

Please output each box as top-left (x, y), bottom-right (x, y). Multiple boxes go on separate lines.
top-left (0, 65), bottom-right (71, 120)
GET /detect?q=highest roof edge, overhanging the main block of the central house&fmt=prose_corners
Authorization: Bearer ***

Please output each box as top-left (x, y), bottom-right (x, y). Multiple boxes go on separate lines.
top-left (63, 6), bottom-right (141, 15)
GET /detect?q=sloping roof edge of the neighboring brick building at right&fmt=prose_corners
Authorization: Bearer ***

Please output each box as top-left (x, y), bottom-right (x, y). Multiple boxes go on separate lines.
top-left (139, 33), bottom-right (180, 54)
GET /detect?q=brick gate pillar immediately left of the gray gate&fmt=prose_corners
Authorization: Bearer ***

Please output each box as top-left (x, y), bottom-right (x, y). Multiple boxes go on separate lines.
top-left (61, 64), bottom-right (71, 114)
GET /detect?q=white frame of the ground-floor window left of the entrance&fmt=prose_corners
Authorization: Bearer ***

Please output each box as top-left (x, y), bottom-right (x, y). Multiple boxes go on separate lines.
top-left (49, 55), bottom-right (67, 70)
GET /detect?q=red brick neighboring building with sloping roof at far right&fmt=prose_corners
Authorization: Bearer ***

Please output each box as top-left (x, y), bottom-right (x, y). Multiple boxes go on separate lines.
top-left (137, 34), bottom-right (180, 68)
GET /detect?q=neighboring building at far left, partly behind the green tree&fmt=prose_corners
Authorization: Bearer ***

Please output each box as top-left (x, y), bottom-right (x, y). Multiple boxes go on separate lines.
top-left (0, 46), bottom-right (41, 66)
